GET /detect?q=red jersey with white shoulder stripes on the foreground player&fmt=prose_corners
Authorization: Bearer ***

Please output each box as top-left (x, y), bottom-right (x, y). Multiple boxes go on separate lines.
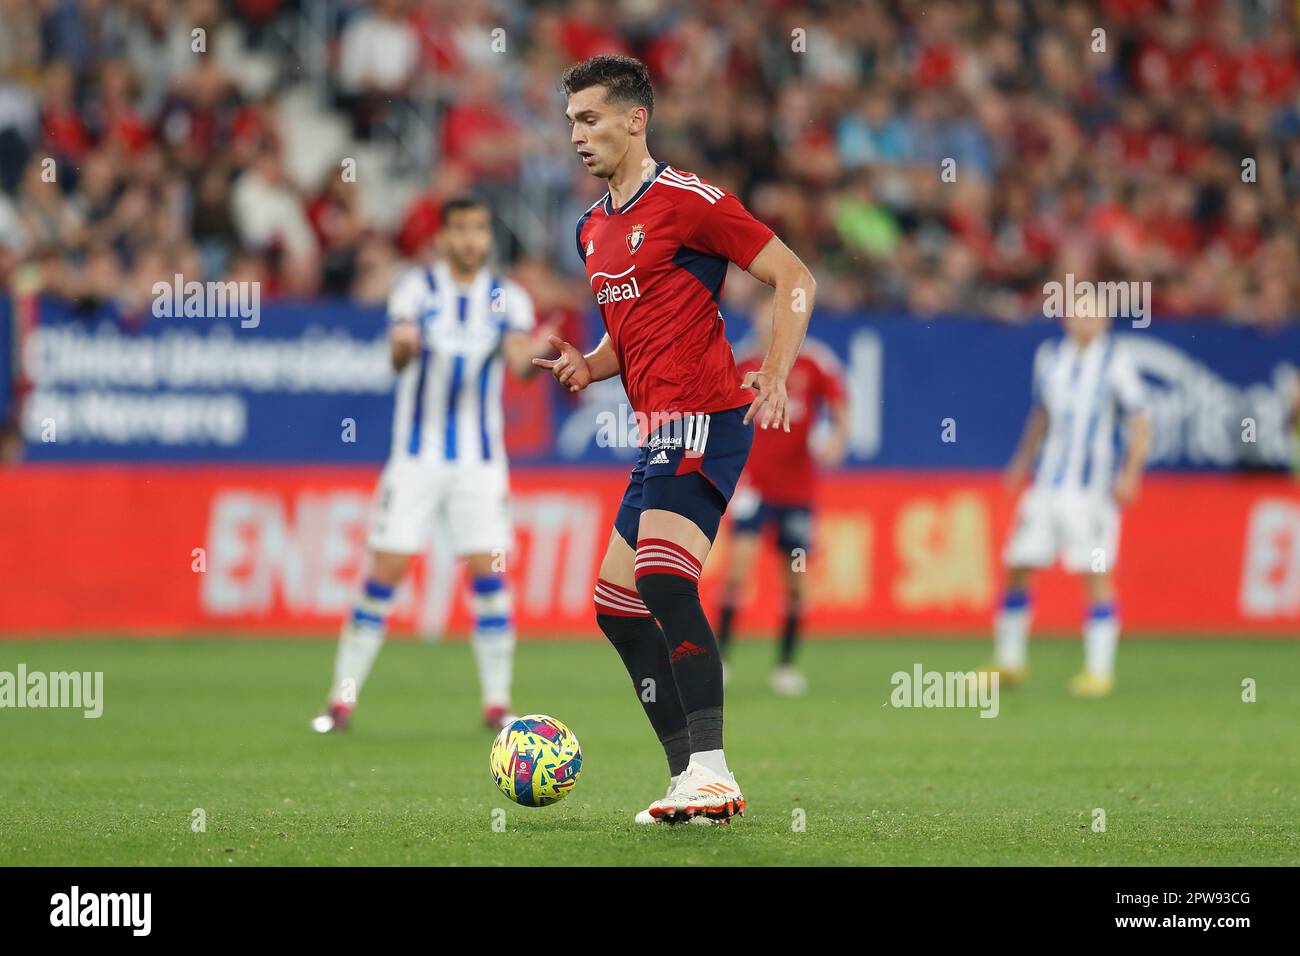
top-left (577, 163), bottom-right (772, 437)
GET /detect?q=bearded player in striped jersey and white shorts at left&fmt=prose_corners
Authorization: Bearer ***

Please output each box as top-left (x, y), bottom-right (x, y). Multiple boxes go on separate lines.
top-left (312, 196), bottom-right (547, 734)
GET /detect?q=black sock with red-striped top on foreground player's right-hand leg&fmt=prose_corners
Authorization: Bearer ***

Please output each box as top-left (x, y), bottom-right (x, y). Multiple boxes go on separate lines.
top-left (636, 538), bottom-right (731, 774)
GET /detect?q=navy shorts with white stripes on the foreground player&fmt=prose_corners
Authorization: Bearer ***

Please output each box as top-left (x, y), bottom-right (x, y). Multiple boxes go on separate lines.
top-left (614, 405), bottom-right (754, 550)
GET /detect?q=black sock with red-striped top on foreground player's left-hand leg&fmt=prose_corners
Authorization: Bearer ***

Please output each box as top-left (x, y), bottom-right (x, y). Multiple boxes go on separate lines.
top-left (595, 579), bottom-right (690, 777)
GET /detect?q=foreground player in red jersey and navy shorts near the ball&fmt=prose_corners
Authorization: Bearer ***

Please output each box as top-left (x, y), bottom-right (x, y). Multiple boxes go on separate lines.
top-left (534, 56), bottom-right (815, 823)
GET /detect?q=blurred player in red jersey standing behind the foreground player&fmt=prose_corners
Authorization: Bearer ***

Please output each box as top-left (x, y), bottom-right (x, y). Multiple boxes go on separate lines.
top-left (718, 312), bottom-right (849, 696)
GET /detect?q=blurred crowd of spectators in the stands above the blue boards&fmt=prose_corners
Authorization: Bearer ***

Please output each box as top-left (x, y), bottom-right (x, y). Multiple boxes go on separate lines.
top-left (0, 0), bottom-right (1300, 324)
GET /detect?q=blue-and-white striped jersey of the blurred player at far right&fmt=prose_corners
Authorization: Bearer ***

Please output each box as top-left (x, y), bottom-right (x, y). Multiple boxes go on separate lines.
top-left (1034, 334), bottom-right (1145, 494)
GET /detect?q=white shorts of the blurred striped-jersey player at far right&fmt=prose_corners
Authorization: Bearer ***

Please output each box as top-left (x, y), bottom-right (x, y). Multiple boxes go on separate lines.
top-left (1002, 488), bottom-right (1119, 574)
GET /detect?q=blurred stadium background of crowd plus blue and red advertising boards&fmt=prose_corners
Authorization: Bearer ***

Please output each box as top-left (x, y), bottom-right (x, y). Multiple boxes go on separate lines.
top-left (0, 0), bottom-right (1300, 639)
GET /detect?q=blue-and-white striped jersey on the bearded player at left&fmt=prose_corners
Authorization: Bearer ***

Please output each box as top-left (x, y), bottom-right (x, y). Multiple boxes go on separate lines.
top-left (389, 263), bottom-right (534, 464)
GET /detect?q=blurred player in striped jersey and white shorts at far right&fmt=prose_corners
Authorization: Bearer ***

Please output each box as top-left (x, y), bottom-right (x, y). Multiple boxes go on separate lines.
top-left (991, 291), bottom-right (1151, 697)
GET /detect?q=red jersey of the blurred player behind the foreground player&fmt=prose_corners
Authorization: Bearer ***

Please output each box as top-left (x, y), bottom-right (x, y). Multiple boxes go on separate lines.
top-left (740, 339), bottom-right (844, 505)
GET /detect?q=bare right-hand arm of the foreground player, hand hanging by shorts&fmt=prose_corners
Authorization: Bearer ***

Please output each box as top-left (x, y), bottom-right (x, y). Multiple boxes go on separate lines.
top-left (741, 235), bottom-right (816, 432)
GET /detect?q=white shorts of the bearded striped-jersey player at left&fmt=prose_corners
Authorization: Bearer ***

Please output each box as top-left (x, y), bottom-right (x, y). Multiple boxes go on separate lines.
top-left (369, 458), bottom-right (515, 555)
